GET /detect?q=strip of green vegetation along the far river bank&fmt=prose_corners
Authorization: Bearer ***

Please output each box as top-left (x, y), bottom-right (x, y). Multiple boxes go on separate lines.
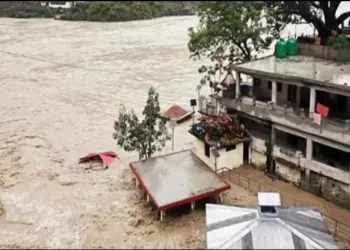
top-left (0, 1), bottom-right (196, 22)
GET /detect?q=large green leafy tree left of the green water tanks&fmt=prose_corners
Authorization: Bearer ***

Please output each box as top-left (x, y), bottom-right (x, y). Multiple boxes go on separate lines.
top-left (188, 1), bottom-right (278, 87)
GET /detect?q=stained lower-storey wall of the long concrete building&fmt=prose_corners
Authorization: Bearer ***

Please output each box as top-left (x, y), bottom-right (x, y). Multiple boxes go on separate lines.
top-left (250, 127), bottom-right (350, 207)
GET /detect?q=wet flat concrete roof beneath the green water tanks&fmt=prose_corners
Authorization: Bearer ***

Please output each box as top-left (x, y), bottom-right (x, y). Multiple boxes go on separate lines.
top-left (233, 55), bottom-right (350, 91)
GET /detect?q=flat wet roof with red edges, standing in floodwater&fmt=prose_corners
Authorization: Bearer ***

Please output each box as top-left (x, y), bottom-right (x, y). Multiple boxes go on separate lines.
top-left (130, 150), bottom-right (231, 209)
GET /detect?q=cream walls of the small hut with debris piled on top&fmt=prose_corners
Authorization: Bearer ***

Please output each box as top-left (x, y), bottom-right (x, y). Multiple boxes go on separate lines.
top-left (194, 137), bottom-right (243, 170)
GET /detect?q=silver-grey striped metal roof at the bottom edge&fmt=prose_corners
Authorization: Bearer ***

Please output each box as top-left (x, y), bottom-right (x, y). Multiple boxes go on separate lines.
top-left (206, 204), bottom-right (339, 249)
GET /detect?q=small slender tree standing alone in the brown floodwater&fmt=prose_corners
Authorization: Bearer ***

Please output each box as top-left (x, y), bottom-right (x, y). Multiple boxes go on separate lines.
top-left (113, 88), bottom-right (170, 160)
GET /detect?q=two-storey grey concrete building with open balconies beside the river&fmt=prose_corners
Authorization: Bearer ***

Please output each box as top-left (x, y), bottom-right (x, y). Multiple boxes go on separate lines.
top-left (216, 46), bottom-right (350, 207)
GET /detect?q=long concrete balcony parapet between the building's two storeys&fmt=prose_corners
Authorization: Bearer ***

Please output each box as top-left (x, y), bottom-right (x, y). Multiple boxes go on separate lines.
top-left (217, 97), bottom-right (350, 145)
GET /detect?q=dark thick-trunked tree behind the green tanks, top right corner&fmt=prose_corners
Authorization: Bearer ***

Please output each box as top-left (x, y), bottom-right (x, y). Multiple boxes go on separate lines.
top-left (266, 1), bottom-right (350, 44)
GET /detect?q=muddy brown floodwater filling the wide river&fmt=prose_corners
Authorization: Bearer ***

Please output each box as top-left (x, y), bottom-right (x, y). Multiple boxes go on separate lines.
top-left (0, 17), bottom-right (260, 248)
